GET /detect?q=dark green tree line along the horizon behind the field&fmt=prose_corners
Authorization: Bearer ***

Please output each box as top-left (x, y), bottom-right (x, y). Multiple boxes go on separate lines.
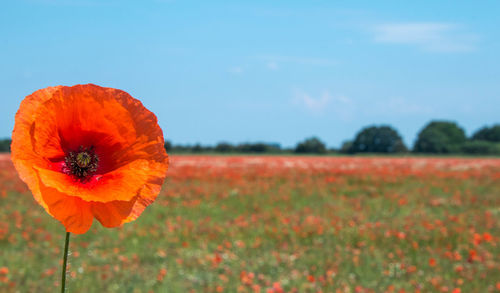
top-left (0, 121), bottom-right (500, 155)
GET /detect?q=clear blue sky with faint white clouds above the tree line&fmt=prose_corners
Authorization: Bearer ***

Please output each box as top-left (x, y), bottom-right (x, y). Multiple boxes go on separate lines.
top-left (0, 0), bottom-right (500, 147)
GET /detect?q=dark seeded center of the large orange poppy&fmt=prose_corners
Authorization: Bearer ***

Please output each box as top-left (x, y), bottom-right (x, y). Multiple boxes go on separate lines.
top-left (63, 146), bottom-right (99, 182)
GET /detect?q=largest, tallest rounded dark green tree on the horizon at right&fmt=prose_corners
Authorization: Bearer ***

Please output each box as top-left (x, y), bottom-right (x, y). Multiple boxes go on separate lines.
top-left (413, 121), bottom-right (467, 154)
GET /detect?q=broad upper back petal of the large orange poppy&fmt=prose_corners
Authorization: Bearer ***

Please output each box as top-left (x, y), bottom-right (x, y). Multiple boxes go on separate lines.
top-left (28, 85), bottom-right (166, 173)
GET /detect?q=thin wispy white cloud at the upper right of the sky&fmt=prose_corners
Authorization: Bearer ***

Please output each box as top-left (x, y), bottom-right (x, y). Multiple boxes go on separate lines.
top-left (371, 22), bottom-right (478, 52)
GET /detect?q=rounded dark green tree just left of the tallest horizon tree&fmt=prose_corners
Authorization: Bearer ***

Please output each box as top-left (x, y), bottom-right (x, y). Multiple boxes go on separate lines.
top-left (350, 125), bottom-right (408, 153)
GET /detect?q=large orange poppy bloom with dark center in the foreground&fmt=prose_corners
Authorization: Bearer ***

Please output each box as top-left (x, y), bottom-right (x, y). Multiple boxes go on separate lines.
top-left (11, 84), bottom-right (168, 234)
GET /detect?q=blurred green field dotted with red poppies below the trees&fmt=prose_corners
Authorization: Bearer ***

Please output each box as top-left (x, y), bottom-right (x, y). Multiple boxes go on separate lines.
top-left (0, 155), bottom-right (500, 293)
